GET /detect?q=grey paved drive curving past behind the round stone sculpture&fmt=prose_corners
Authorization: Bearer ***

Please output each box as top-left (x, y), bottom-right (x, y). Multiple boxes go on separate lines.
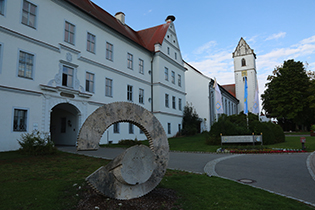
top-left (59, 147), bottom-right (315, 206)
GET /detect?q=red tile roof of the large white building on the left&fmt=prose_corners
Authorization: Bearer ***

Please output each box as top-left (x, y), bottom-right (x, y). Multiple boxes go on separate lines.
top-left (65, 0), bottom-right (170, 52)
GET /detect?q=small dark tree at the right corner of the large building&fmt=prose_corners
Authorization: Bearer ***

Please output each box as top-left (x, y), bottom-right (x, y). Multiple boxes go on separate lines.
top-left (182, 103), bottom-right (201, 136)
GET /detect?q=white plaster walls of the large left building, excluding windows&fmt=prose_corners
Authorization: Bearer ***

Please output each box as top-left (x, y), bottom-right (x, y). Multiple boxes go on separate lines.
top-left (0, 0), bottom-right (186, 151)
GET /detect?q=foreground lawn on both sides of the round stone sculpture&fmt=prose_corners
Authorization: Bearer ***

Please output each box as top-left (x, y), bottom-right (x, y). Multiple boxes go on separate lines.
top-left (0, 152), bottom-right (314, 210)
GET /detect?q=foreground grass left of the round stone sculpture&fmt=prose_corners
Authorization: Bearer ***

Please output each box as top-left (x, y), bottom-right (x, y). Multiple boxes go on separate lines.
top-left (0, 152), bottom-right (108, 210)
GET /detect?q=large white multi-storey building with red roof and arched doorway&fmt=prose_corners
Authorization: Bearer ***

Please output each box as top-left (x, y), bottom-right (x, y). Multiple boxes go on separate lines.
top-left (0, 0), bottom-right (186, 151)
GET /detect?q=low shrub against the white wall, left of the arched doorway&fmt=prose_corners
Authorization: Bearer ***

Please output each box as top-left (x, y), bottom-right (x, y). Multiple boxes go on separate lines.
top-left (18, 131), bottom-right (57, 155)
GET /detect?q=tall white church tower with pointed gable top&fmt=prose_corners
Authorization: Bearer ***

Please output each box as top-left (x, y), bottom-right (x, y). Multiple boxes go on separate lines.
top-left (233, 38), bottom-right (258, 112)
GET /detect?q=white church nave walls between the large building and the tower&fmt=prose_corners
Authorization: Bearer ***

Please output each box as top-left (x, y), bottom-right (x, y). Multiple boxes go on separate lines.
top-left (184, 62), bottom-right (239, 132)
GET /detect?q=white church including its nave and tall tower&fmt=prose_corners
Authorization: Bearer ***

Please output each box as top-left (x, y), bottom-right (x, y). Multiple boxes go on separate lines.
top-left (184, 38), bottom-right (258, 131)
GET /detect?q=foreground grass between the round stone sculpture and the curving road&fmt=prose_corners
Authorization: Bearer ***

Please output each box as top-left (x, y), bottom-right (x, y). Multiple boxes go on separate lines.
top-left (159, 170), bottom-right (314, 210)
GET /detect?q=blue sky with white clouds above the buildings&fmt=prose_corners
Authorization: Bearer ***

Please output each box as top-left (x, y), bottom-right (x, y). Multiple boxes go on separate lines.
top-left (92, 0), bottom-right (315, 111)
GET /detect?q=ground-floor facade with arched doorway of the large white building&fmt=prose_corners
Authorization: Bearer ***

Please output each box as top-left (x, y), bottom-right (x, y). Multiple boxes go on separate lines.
top-left (0, 88), bottom-right (182, 151)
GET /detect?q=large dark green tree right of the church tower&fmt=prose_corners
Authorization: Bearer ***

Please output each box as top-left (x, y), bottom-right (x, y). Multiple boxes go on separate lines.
top-left (261, 60), bottom-right (310, 130)
